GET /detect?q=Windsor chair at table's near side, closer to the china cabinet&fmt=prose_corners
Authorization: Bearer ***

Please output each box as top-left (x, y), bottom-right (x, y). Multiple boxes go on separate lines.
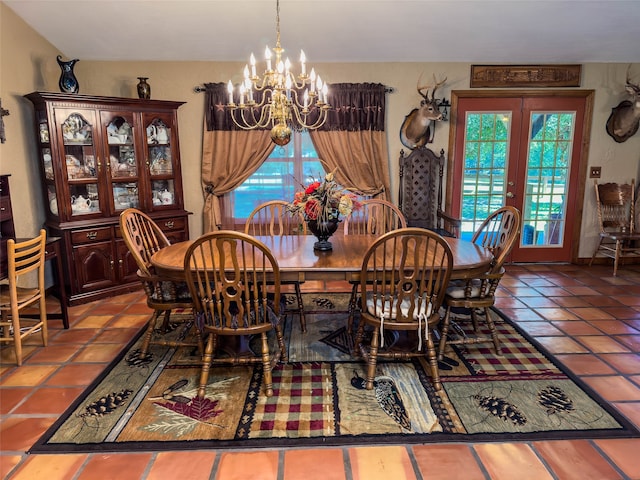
top-left (184, 230), bottom-right (288, 398)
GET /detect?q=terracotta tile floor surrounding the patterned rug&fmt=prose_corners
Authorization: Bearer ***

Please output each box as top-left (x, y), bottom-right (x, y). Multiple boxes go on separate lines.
top-left (0, 265), bottom-right (640, 480)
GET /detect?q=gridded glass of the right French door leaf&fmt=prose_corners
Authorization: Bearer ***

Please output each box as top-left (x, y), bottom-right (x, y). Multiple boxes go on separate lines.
top-left (520, 112), bottom-right (575, 247)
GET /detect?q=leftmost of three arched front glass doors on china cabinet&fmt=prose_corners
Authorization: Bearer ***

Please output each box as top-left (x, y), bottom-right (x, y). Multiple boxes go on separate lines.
top-left (59, 111), bottom-right (100, 217)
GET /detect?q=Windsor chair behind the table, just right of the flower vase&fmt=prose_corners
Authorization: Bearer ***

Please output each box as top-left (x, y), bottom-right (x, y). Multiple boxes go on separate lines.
top-left (344, 198), bottom-right (407, 332)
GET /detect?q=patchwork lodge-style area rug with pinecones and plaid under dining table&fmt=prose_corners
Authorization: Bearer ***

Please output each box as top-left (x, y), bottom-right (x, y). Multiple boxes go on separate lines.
top-left (30, 294), bottom-right (639, 453)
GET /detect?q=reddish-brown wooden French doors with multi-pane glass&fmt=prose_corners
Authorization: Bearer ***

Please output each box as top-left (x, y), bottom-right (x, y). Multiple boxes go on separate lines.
top-left (447, 91), bottom-right (592, 262)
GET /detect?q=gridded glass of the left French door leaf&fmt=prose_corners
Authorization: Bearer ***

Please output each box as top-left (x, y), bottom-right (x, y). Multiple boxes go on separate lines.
top-left (460, 112), bottom-right (511, 239)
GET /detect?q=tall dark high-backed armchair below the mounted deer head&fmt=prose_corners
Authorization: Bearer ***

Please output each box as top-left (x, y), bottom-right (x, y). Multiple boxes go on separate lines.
top-left (398, 147), bottom-right (462, 237)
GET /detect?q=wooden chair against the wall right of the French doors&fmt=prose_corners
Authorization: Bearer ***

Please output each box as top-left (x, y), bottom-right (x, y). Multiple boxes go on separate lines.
top-left (589, 180), bottom-right (640, 277)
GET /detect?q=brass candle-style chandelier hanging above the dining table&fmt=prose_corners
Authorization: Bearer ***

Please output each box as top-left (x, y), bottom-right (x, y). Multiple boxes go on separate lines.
top-left (227, 0), bottom-right (330, 145)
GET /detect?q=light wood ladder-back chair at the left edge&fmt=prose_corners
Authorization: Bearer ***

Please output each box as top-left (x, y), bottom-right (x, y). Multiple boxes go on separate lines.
top-left (0, 230), bottom-right (48, 366)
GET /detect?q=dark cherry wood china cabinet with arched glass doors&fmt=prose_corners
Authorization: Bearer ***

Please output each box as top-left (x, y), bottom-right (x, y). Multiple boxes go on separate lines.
top-left (26, 92), bottom-right (190, 305)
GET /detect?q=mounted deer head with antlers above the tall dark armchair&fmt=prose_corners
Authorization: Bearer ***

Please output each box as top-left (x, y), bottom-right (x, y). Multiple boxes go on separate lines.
top-left (400, 75), bottom-right (447, 150)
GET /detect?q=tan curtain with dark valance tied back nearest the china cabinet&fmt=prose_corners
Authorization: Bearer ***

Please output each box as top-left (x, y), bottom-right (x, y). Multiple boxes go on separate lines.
top-left (202, 83), bottom-right (275, 233)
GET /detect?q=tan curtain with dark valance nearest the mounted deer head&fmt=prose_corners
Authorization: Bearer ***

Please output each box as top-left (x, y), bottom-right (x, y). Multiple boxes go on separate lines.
top-left (309, 83), bottom-right (390, 200)
